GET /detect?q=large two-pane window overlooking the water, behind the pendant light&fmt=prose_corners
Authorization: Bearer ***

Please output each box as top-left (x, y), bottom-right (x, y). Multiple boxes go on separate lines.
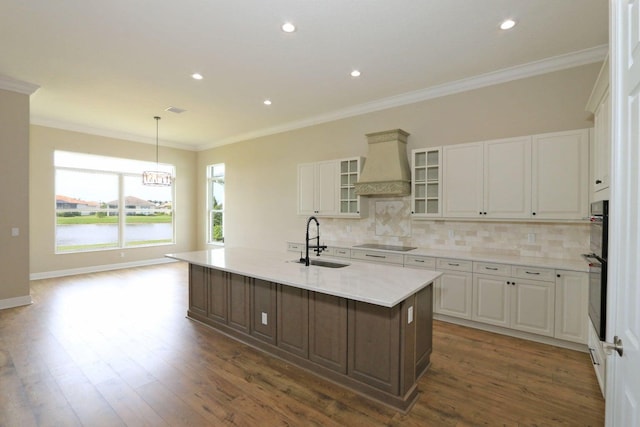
top-left (54, 151), bottom-right (175, 253)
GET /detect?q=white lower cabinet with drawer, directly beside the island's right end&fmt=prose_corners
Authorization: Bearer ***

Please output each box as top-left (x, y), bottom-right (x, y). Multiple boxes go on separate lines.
top-left (433, 258), bottom-right (473, 319)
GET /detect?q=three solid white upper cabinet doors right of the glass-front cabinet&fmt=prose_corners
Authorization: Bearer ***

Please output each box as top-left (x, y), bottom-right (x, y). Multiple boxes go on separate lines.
top-left (442, 129), bottom-right (589, 220)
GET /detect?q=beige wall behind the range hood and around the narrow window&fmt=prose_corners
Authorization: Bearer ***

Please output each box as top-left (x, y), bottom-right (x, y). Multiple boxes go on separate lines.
top-left (197, 63), bottom-right (601, 251)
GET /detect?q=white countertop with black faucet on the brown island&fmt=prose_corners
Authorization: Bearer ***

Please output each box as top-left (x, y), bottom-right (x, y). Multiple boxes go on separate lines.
top-left (166, 248), bottom-right (442, 307)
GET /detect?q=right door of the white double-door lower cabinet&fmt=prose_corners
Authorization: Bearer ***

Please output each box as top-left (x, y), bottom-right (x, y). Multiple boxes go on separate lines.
top-left (510, 279), bottom-right (555, 337)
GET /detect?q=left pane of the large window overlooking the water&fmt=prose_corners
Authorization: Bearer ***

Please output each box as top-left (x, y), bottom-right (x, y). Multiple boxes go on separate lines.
top-left (55, 169), bottom-right (118, 252)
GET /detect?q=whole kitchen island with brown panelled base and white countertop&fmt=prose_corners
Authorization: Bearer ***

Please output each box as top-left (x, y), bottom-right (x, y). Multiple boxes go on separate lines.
top-left (167, 248), bottom-right (440, 411)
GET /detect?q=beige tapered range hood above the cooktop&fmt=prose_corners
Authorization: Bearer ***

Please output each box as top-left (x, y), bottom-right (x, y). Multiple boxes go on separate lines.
top-left (355, 129), bottom-right (411, 196)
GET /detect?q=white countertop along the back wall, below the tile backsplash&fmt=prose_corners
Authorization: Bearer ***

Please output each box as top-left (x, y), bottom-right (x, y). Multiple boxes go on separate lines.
top-left (304, 241), bottom-right (589, 272)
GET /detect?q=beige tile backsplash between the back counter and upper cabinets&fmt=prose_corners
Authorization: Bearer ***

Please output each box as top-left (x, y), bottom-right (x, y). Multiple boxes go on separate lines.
top-left (321, 197), bottom-right (589, 259)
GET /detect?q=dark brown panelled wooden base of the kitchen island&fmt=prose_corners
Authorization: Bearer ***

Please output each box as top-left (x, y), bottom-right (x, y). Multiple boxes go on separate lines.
top-left (188, 264), bottom-right (433, 411)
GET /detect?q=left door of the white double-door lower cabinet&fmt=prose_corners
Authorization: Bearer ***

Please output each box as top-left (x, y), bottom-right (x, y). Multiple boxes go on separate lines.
top-left (471, 274), bottom-right (511, 328)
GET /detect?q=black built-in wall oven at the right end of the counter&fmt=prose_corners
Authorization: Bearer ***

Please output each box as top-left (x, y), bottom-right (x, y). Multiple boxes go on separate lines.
top-left (583, 200), bottom-right (609, 341)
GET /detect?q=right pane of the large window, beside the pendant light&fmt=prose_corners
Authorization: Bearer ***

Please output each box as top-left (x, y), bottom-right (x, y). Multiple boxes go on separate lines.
top-left (122, 175), bottom-right (173, 246)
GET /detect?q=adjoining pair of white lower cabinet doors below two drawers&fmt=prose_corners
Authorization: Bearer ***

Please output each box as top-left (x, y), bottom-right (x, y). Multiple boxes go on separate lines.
top-left (472, 274), bottom-right (555, 337)
